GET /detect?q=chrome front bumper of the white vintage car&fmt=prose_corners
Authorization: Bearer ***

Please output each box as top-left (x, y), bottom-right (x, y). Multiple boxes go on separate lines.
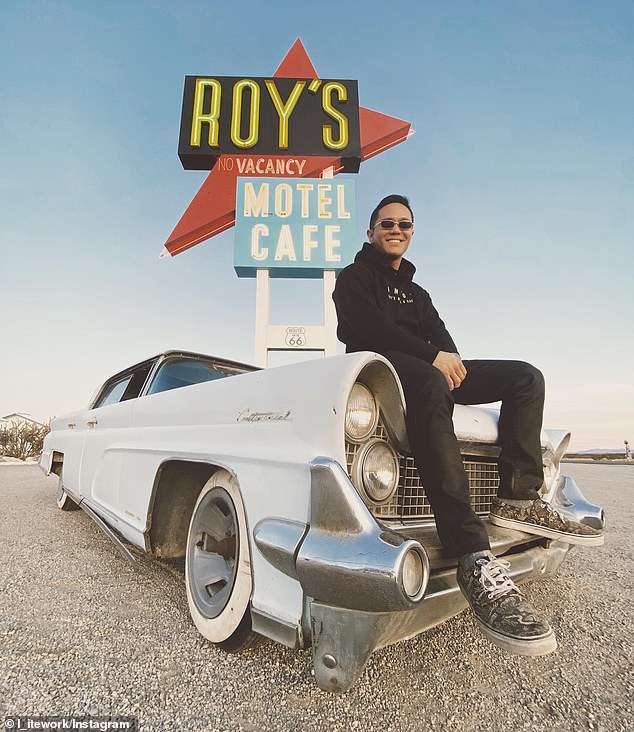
top-left (254, 458), bottom-right (603, 691)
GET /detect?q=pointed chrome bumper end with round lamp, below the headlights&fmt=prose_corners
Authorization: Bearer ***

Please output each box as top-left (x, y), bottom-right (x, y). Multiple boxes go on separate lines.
top-left (295, 457), bottom-right (429, 612)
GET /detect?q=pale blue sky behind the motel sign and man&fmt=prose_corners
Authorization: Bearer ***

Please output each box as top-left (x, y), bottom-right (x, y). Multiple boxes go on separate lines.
top-left (0, 0), bottom-right (634, 449)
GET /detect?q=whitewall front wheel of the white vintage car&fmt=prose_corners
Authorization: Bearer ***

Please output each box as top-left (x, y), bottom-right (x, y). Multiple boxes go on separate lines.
top-left (185, 470), bottom-right (255, 651)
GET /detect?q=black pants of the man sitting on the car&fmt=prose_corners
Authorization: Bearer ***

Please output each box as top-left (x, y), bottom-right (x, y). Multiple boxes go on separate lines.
top-left (383, 351), bottom-right (544, 555)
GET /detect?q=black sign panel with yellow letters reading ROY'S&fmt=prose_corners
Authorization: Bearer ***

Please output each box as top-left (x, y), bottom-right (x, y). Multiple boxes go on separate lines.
top-left (178, 76), bottom-right (361, 175)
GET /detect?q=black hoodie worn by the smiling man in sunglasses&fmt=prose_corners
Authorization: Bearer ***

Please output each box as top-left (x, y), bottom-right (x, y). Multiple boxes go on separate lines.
top-left (332, 242), bottom-right (457, 363)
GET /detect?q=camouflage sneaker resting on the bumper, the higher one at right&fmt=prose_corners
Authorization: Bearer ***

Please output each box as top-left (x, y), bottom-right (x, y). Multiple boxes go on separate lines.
top-left (489, 498), bottom-right (603, 546)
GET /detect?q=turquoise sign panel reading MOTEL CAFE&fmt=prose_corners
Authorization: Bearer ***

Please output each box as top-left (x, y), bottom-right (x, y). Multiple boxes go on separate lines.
top-left (234, 178), bottom-right (359, 278)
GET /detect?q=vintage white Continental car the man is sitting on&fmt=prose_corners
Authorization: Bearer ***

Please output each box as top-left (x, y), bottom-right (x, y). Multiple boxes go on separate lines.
top-left (40, 351), bottom-right (603, 691)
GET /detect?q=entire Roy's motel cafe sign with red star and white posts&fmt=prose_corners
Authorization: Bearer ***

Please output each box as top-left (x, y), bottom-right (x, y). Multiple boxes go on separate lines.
top-left (161, 39), bottom-right (411, 366)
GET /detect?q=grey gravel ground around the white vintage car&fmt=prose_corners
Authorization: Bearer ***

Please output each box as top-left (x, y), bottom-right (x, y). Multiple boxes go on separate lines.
top-left (0, 464), bottom-right (634, 732)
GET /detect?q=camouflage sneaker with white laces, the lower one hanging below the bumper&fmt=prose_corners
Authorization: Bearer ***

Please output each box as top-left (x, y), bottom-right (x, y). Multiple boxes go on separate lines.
top-left (457, 556), bottom-right (557, 656)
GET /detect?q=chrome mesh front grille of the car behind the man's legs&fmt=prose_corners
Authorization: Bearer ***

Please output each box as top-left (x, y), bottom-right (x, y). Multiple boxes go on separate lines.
top-left (346, 420), bottom-right (500, 520)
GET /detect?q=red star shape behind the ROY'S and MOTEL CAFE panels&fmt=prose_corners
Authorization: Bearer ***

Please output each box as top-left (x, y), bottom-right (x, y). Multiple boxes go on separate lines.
top-left (160, 38), bottom-right (413, 257)
